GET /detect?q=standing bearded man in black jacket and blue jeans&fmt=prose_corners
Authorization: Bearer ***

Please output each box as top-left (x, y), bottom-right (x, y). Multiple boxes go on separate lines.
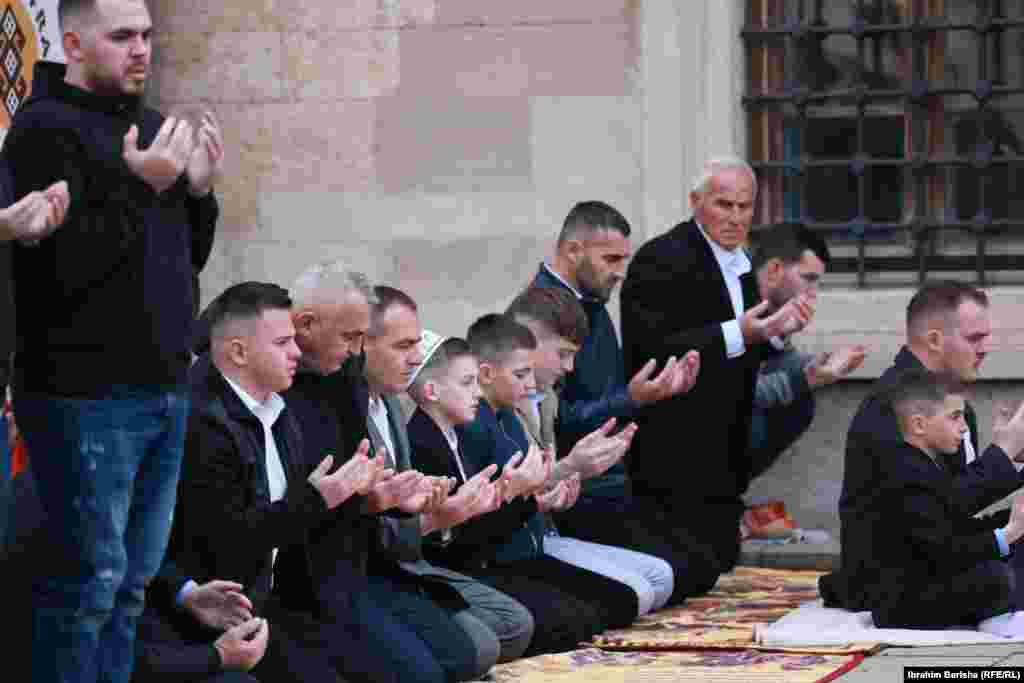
top-left (5, 0), bottom-right (223, 683)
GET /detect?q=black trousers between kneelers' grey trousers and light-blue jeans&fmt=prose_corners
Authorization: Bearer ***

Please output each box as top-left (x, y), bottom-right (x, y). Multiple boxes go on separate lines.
top-left (459, 555), bottom-right (638, 656)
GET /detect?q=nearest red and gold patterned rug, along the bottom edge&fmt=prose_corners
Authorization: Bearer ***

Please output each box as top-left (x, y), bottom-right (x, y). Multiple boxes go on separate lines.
top-left (493, 648), bottom-right (863, 683)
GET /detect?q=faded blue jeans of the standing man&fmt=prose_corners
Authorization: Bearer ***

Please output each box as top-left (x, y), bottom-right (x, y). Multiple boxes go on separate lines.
top-left (14, 387), bottom-right (188, 683)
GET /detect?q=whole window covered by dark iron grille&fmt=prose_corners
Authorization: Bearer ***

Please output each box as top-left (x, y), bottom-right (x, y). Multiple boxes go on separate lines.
top-left (742, 0), bottom-right (1024, 287)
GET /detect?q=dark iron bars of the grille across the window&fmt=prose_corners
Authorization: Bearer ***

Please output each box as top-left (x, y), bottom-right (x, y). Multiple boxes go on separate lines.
top-left (741, 0), bottom-right (1024, 287)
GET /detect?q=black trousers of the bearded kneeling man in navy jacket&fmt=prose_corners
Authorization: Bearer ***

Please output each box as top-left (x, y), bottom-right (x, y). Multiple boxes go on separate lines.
top-left (555, 497), bottom-right (735, 606)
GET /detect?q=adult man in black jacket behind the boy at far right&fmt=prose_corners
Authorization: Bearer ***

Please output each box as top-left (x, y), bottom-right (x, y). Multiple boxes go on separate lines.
top-left (820, 281), bottom-right (1024, 609)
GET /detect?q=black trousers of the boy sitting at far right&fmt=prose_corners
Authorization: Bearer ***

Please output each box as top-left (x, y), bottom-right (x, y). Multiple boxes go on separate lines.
top-left (871, 560), bottom-right (1016, 629)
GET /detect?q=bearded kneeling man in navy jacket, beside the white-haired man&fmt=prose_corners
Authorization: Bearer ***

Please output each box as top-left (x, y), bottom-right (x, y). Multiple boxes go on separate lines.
top-left (534, 202), bottom-right (718, 605)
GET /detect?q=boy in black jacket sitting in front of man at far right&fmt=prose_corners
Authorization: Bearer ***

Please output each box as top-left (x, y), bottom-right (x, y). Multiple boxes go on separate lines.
top-left (844, 370), bottom-right (1024, 630)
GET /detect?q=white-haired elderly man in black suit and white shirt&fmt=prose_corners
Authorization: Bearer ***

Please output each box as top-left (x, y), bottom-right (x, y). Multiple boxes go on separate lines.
top-left (622, 158), bottom-right (813, 589)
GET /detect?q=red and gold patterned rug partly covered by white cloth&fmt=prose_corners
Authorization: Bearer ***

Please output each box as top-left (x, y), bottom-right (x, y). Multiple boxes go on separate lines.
top-left (588, 567), bottom-right (878, 654)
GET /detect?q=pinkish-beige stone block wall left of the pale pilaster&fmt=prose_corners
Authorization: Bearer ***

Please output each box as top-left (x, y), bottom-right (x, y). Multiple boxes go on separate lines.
top-left (151, 0), bottom-right (644, 334)
